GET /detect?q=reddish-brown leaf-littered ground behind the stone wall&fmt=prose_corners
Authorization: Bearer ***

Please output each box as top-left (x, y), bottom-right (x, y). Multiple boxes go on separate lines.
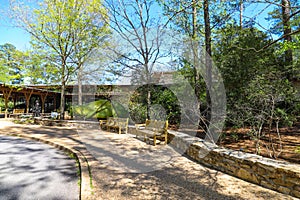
top-left (218, 122), bottom-right (300, 164)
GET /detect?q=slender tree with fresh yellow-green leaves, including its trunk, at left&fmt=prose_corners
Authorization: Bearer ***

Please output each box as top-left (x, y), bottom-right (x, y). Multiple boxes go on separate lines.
top-left (11, 0), bottom-right (111, 116)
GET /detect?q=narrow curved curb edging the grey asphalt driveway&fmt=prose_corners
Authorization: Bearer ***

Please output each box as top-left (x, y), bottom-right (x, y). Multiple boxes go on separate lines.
top-left (1, 134), bottom-right (94, 200)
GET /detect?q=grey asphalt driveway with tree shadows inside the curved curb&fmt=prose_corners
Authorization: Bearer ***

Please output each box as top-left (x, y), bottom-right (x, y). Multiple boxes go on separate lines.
top-left (0, 136), bottom-right (79, 200)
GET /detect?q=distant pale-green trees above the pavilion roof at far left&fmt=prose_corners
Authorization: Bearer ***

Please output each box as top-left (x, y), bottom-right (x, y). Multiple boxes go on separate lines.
top-left (0, 44), bottom-right (60, 84)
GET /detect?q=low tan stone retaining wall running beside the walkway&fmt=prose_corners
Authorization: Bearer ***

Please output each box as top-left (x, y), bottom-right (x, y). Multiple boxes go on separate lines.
top-left (169, 131), bottom-right (300, 198)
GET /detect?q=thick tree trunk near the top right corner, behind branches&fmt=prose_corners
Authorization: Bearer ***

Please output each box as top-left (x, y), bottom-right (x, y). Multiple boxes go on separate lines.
top-left (281, 0), bottom-right (293, 70)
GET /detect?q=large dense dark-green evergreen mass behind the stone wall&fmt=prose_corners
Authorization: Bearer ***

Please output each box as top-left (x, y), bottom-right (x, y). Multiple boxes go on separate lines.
top-left (215, 25), bottom-right (296, 126)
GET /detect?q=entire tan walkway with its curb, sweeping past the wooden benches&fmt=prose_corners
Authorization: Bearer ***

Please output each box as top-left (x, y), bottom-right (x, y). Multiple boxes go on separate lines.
top-left (0, 121), bottom-right (296, 200)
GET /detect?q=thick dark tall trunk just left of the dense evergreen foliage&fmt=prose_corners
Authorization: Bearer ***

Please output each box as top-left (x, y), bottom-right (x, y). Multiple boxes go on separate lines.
top-left (203, 0), bottom-right (212, 122)
